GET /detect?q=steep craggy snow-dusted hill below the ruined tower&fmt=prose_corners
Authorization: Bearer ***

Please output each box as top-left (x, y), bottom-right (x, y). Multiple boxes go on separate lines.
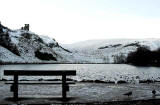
top-left (0, 24), bottom-right (70, 63)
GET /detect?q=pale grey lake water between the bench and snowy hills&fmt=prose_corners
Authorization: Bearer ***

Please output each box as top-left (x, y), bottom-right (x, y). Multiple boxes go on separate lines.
top-left (0, 64), bottom-right (160, 83)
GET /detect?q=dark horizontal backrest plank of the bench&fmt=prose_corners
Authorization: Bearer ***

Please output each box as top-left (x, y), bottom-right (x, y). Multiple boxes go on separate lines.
top-left (4, 70), bottom-right (76, 76)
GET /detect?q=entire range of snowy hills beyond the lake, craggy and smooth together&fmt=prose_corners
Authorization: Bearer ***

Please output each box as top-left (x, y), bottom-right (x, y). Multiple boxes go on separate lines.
top-left (0, 24), bottom-right (160, 63)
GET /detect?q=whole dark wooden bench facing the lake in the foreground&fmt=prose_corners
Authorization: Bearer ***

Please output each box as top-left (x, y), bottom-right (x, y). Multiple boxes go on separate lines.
top-left (4, 70), bottom-right (76, 100)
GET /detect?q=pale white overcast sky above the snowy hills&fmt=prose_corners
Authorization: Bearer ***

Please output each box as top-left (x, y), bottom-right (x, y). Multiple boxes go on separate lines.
top-left (0, 0), bottom-right (160, 44)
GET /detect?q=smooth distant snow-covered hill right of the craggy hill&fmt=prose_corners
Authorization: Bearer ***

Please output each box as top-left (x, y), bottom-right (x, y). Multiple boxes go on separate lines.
top-left (62, 39), bottom-right (160, 63)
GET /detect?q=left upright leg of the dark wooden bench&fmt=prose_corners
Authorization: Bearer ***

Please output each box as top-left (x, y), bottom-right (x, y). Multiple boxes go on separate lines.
top-left (13, 75), bottom-right (18, 100)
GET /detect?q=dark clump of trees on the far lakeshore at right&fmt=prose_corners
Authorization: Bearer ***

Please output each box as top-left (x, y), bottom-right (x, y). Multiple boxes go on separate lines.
top-left (126, 46), bottom-right (160, 66)
